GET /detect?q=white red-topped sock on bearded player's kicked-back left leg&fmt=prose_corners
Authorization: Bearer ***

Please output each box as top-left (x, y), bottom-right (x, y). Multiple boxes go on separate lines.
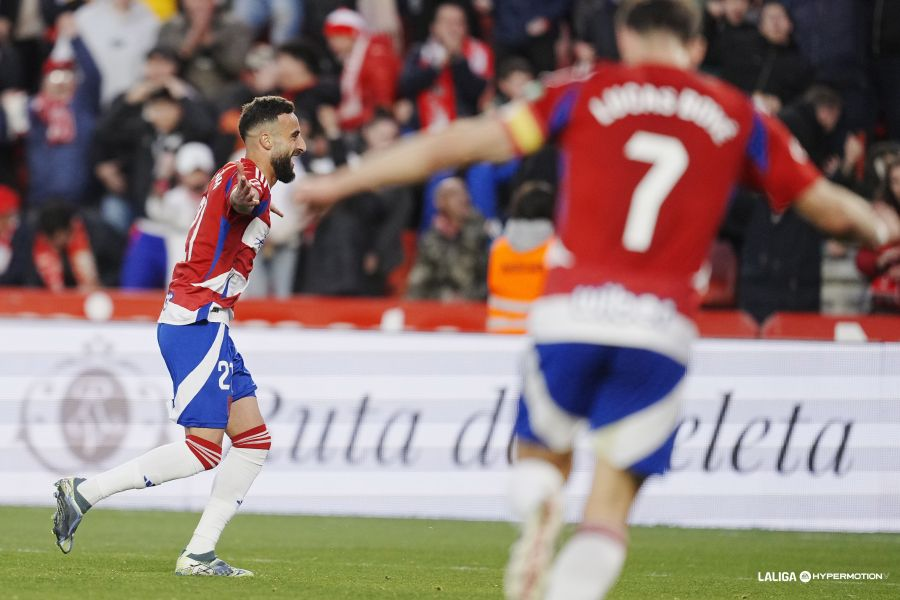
top-left (77, 435), bottom-right (222, 510)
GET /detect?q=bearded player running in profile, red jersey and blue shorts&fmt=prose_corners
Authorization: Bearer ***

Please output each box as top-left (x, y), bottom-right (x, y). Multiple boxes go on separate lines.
top-left (53, 96), bottom-right (306, 577)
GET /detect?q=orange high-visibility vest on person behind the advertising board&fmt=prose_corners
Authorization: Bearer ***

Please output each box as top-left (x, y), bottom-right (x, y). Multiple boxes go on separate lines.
top-left (487, 236), bottom-right (556, 333)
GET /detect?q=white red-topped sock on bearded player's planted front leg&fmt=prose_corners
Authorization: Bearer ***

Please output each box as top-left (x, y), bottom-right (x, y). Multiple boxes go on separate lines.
top-left (186, 425), bottom-right (272, 555)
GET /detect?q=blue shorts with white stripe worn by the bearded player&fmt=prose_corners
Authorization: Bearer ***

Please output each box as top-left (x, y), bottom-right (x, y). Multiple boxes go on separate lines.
top-left (156, 321), bottom-right (256, 429)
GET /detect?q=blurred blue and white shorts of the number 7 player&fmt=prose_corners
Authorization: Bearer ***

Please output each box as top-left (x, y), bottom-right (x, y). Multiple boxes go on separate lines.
top-left (515, 343), bottom-right (687, 475)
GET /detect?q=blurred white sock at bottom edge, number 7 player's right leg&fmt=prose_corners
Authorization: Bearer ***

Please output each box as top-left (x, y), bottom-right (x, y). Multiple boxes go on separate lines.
top-left (546, 525), bottom-right (627, 600)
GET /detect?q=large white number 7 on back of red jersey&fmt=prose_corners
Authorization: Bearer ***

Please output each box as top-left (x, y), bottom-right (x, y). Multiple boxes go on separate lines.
top-left (622, 131), bottom-right (688, 252)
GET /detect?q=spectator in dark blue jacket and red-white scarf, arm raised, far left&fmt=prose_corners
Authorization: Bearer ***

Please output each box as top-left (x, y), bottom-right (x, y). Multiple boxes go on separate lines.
top-left (26, 15), bottom-right (100, 208)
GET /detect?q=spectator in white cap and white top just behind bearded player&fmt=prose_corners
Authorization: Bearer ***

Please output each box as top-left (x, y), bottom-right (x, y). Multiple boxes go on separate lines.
top-left (120, 142), bottom-right (216, 289)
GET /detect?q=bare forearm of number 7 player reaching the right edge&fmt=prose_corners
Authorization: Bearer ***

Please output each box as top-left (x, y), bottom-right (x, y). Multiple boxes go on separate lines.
top-left (794, 177), bottom-right (900, 248)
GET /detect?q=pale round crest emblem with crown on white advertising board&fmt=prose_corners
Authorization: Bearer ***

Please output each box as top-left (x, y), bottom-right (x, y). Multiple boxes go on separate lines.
top-left (21, 338), bottom-right (167, 472)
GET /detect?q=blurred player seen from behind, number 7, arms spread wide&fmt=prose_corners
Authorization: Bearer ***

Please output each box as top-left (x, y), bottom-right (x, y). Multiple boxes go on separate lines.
top-left (300, 0), bottom-right (900, 600)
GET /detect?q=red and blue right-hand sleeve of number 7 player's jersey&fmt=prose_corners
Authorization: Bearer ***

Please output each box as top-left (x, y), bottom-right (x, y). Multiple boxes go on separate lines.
top-left (743, 111), bottom-right (822, 212)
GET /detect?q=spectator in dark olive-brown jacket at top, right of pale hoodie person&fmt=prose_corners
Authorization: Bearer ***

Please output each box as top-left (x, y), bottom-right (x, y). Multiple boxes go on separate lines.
top-left (158, 0), bottom-right (252, 100)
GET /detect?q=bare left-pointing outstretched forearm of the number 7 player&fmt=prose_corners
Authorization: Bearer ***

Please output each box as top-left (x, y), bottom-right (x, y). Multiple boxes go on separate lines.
top-left (299, 116), bottom-right (516, 210)
